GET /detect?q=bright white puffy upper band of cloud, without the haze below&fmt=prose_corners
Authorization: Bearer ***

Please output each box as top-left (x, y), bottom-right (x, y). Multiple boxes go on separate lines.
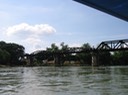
top-left (6, 23), bottom-right (56, 36)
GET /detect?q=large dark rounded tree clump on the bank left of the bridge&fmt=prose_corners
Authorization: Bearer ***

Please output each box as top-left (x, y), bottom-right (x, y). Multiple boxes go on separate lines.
top-left (0, 41), bottom-right (25, 66)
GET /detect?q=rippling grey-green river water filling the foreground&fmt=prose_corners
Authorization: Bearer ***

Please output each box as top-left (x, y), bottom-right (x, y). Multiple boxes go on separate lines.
top-left (0, 66), bottom-right (128, 95)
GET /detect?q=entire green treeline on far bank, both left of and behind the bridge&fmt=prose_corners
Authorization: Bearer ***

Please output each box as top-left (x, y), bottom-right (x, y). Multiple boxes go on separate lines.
top-left (0, 41), bottom-right (128, 66)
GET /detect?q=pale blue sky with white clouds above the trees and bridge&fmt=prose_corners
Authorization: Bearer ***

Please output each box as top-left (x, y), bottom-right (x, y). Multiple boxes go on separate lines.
top-left (0, 0), bottom-right (128, 53)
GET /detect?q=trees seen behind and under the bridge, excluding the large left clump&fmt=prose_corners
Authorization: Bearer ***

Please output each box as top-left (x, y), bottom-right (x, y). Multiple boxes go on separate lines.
top-left (32, 42), bottom-right (128, 66)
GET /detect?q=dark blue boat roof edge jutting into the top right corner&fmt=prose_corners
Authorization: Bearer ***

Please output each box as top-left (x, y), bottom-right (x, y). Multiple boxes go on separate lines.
top-left (74, 0), bottom-right (128, 21)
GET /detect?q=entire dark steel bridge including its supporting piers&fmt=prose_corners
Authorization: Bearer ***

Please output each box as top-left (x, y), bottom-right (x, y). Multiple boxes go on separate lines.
top-left (27, 39), bottom-right (128, 65)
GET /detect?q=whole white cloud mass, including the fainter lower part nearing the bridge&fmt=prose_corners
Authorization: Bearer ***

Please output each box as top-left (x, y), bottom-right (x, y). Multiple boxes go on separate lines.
top-left (4, 23), bottom-right (56, 52)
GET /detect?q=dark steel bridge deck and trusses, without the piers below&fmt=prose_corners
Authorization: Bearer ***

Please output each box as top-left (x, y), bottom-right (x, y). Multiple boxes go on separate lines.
top-left (30, 39), bottom-right (128, 55)
